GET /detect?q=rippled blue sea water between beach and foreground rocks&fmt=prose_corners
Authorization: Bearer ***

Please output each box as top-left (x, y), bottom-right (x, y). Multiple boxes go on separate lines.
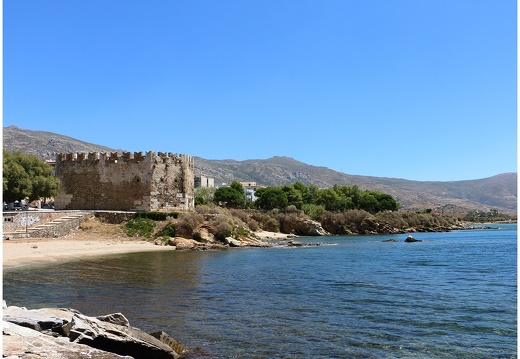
top-left (3, 224), bottom-right (518, 358)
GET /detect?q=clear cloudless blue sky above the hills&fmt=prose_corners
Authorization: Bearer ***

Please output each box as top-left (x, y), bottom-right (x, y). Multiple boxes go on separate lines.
top-left (3, 0), bottom-right (517, 181)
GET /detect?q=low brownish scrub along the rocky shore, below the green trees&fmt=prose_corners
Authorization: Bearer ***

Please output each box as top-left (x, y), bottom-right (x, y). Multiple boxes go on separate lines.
top-left (126, 204), bottom-right (464, 242)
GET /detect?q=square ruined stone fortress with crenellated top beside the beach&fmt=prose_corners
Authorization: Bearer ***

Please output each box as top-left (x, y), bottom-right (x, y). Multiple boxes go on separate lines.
top-left (54, 151), bottom-right (195, 212)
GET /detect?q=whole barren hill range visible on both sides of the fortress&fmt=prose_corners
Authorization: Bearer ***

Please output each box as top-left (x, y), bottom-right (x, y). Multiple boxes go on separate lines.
top-left (3, 126), bottom-right (517, 214)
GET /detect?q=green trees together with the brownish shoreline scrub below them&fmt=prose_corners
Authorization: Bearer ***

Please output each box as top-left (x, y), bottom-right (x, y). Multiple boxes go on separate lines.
top-left (146, 181), bottom-right (480, 241)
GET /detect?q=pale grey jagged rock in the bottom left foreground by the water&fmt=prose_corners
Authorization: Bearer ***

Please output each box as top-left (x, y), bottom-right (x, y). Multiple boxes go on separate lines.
top-left (3, 306), bottom-right (185, 359)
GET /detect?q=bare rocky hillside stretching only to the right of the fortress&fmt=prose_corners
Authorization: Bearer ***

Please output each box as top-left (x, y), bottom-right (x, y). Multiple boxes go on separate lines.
top-left (195, 157), bottom-right (517, 214)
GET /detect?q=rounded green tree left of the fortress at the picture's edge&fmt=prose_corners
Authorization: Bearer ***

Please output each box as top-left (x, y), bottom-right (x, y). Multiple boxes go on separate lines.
top-left (2, 151), bottom-right (59, 202)
